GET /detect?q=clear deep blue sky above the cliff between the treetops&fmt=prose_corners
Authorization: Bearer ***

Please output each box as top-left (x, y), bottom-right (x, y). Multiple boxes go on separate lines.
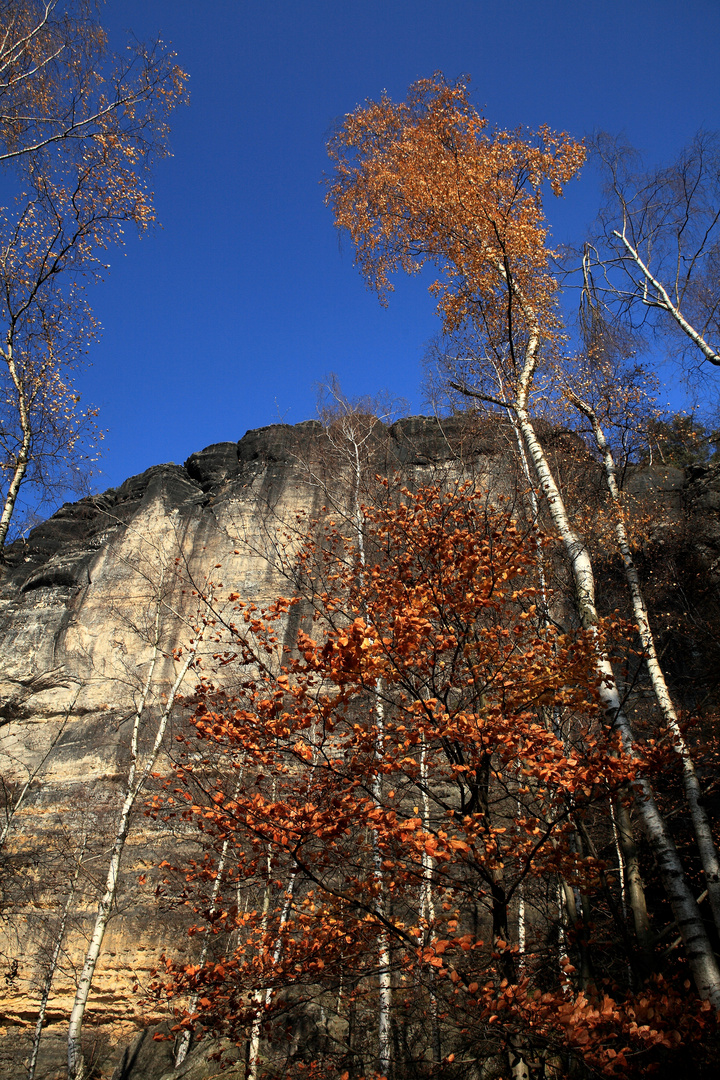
top-left (80, 0), bottom-right (720, 489)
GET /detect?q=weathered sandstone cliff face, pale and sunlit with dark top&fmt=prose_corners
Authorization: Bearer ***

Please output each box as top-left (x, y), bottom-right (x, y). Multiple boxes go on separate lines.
top-left (0, 417), bottom-right (720, 1080)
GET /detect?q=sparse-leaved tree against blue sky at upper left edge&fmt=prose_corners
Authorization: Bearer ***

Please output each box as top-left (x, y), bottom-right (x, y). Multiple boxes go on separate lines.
top-left (0, 0), bottom-right (186, 545)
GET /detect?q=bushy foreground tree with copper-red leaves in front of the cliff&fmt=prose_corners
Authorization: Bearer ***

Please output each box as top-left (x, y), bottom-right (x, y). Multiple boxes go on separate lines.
top-left (154, 485), bottom-right (714, 1076)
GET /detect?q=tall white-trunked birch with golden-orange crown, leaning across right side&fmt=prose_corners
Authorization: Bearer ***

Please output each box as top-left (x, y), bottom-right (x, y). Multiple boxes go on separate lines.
top-left (328, 77), bottom-right (720, 1007)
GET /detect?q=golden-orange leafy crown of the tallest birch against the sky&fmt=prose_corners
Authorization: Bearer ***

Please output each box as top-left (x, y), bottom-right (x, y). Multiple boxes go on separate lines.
top-left (327, 76), bottom-right (585, 347)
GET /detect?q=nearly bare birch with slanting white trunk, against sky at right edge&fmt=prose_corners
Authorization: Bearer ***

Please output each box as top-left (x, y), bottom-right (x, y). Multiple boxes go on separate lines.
top-left (583, 132), bottom-right (720, 367)
